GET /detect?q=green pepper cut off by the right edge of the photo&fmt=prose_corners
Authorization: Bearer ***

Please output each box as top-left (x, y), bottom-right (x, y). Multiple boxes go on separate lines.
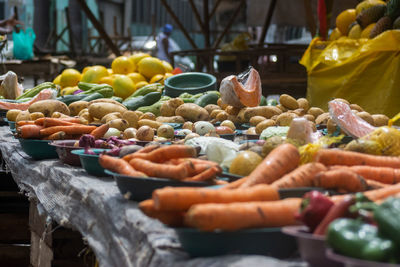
top-left (374, 197), bottom-right (400, 247)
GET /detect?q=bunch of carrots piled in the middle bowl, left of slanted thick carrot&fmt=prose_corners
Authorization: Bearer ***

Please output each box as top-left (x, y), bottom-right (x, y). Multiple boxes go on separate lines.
top-left (99, 145), bottom-right (222, 183)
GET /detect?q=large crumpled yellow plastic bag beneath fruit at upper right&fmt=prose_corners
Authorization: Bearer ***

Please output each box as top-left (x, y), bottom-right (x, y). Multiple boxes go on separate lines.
top-left (300, 30), bottom-right (400, 117)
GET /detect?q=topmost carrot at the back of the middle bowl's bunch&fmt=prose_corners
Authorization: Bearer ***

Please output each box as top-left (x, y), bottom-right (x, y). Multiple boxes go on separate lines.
top-left (124, 145), bottom-right (197, 163)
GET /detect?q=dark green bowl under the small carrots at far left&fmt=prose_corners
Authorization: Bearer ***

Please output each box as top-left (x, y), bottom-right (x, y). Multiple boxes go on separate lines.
top-left (18, 138), bottom-right (58, 160)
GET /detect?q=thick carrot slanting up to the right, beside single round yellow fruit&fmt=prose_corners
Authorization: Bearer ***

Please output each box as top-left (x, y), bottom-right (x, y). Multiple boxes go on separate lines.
top-left (240, 144), bottom-right (300, 188)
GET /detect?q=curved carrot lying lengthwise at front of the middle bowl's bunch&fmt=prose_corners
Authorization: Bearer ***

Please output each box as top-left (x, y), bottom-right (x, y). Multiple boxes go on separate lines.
top-left (129, 158), bottom-right (193, 180)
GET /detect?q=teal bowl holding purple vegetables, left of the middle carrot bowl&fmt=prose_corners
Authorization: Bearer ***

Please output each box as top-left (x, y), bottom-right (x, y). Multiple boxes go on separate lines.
top-left (71, 148), bottom-right (110, 176)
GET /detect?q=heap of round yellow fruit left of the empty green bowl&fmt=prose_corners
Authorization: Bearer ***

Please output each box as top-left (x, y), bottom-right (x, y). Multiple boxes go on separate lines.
top-left (53, 53), bottom-right (173, 98)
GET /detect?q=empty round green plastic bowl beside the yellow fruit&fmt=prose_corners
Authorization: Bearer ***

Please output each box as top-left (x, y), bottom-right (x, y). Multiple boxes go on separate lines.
top-left (164, 72), bottom-right (217, 97)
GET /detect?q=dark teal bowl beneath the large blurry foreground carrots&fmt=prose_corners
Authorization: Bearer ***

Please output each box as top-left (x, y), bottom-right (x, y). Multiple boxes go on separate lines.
top-left (175, 228), bottom-right (297, 258)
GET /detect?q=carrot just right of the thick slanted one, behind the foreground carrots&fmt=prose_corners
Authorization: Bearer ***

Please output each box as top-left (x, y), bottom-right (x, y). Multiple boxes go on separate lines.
top-left (271, 163), bottom-right (326, 189)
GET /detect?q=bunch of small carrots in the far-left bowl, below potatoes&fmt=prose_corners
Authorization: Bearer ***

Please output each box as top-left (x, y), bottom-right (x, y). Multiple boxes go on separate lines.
top-left (16, 117), bottom-right (108, 140)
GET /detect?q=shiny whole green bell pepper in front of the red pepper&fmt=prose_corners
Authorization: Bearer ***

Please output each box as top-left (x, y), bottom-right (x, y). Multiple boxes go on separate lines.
top-left (326, 218), bottom-right (396, 262)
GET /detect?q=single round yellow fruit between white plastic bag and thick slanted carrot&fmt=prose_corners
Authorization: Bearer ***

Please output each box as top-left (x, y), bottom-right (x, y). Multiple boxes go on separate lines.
top-left (229, 150), bottom-right (262, 176)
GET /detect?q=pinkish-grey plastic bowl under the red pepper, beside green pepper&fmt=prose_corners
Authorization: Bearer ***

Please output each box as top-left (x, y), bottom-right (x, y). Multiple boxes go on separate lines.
top-left (282, 226), bottom-right (343, 267)
